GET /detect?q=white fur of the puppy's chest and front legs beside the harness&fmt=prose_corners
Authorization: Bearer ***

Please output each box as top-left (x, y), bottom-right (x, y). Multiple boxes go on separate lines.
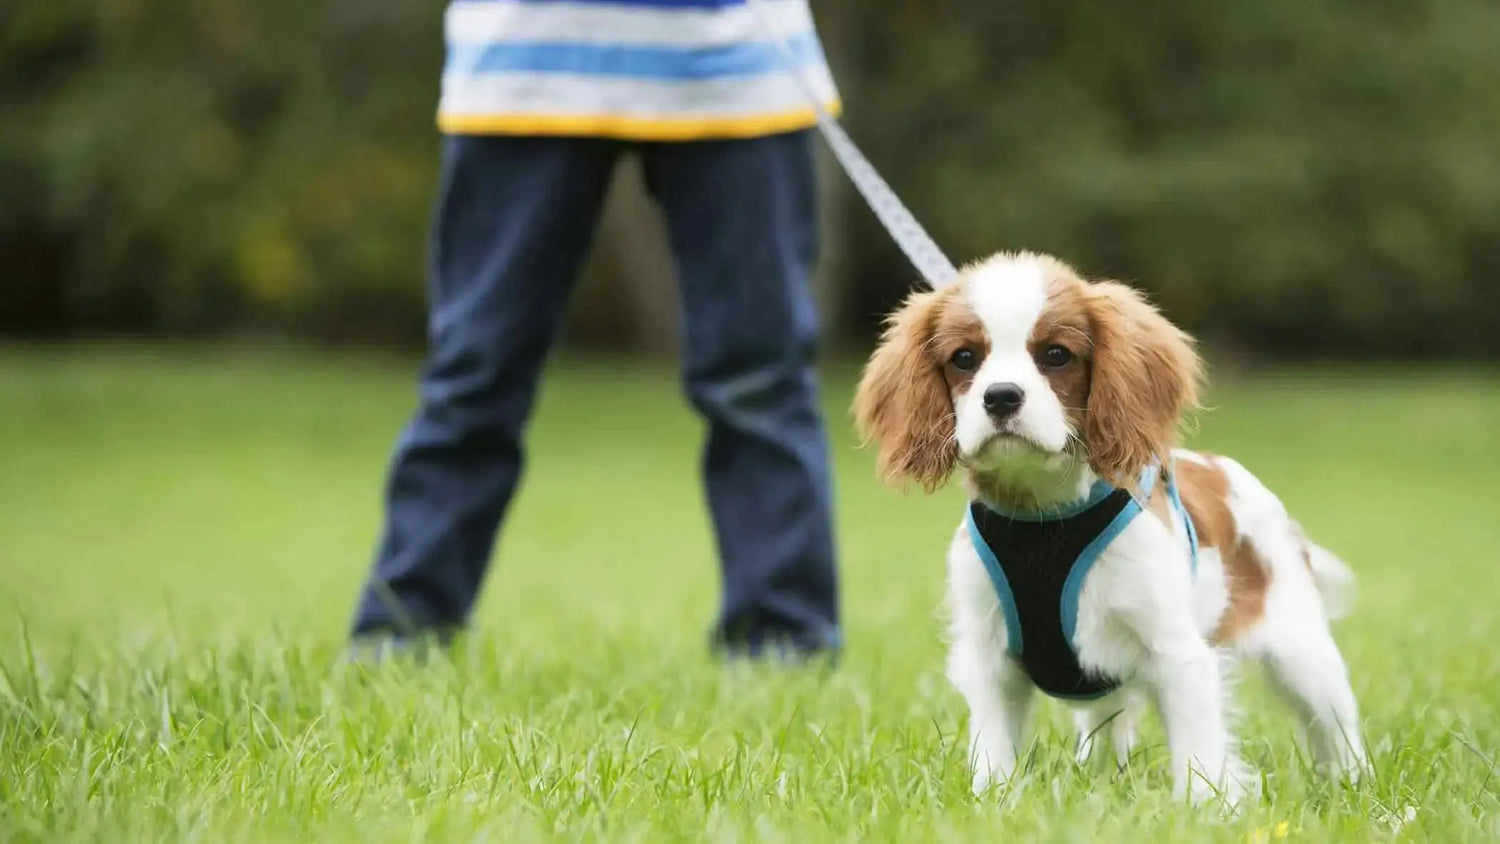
top-left (948, 491), bottom-right (1250, 799)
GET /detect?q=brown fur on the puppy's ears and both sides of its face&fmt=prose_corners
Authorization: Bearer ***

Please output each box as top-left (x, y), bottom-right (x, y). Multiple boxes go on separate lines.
top-left (854, 258), bottom-right (1202, 492)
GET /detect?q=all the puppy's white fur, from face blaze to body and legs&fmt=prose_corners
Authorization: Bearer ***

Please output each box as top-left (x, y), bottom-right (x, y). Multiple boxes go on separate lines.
top-left (948, 256), bottom-right (1365, 802)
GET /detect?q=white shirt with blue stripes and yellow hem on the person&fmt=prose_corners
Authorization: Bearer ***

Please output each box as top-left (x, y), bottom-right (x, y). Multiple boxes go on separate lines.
top-left (438, 0), bottom-right (839, 141)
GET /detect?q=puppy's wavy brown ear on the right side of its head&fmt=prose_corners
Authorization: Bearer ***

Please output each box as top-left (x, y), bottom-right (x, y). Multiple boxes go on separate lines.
top-left (1083, 282), bottom-right (1203, 487)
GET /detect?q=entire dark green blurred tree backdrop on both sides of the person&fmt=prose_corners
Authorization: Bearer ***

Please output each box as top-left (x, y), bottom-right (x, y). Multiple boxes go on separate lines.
top-left (0, 0), bottom-right (1500, 357)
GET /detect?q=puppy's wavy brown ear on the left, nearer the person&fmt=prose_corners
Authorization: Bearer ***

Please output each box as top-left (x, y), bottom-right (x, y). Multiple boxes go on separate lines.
top-left (854, 292), bottom-right (959, 492)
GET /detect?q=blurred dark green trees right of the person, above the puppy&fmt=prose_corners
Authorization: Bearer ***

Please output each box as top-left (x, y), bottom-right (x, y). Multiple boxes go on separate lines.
top-left (845, 0), bottom-right (1500, 355)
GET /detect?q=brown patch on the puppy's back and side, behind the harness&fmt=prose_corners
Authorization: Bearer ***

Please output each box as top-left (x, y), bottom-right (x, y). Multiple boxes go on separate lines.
top-left (1175, 454), bottom-right (1271, 645)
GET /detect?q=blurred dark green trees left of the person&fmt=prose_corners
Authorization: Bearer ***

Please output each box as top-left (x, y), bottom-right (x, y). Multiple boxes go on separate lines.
top-left (0, 0), bottom-right (443, 339)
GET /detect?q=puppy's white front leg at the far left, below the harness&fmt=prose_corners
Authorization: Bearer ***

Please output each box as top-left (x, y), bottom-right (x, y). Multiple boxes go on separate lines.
top-left (948, 640), bottom-right (1034, 795)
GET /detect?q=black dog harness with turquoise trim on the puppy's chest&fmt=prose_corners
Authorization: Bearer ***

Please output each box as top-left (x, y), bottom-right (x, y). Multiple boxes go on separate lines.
top-left (968, 466), bottom-right (1199, 700)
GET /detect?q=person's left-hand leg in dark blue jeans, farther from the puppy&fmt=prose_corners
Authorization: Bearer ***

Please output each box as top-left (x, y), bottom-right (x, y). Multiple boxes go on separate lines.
top-left (354, 136), bottom-right (620, 637)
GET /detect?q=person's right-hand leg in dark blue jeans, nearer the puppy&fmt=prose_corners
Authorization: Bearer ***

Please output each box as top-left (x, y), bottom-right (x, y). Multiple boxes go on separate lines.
top-left (644, 132), bottom-right (840, 654)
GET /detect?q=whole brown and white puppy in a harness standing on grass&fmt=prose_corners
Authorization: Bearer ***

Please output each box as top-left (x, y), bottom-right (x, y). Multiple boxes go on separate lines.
top-left (855, 253), bottom-right (1365, 802)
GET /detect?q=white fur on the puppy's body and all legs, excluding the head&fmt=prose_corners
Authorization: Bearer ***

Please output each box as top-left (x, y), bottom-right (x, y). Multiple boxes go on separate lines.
top-left (948, 454), bottom-right (1364, 802)
